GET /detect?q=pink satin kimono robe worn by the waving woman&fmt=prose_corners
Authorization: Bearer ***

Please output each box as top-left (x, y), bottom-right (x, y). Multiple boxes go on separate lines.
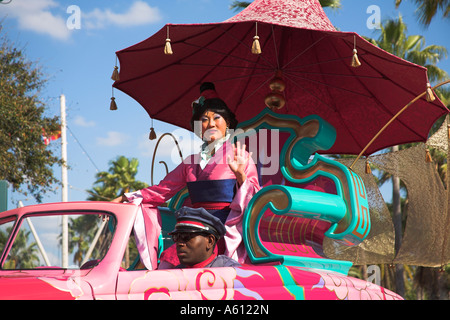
top-left (126, 141), bottom-right (261, 269)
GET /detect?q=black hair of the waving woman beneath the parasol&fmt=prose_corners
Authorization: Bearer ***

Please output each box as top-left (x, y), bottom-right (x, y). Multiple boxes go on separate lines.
top-left (191, 82), bottom-right (238, 135)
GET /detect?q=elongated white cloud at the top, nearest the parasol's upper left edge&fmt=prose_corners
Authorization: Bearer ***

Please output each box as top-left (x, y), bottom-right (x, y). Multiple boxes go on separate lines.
top-left (82, 1), bottom-right (161, 28)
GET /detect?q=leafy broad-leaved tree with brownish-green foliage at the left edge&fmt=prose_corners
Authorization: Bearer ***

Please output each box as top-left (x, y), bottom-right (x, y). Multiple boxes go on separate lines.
top-left (0, 25), bottom-right (61, 202)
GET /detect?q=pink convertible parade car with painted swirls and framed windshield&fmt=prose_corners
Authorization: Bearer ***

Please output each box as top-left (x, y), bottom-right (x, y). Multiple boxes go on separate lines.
top-left (0, 202), bottom-right (402, 302)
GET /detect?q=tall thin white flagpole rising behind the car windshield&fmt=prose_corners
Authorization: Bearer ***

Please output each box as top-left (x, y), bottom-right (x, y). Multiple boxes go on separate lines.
top-left (60, 94), bottom-right (69, 268)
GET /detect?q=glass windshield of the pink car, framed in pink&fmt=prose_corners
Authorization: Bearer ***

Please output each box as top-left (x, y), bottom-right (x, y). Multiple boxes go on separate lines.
top-left (0, 212), bottom-right (115, 270)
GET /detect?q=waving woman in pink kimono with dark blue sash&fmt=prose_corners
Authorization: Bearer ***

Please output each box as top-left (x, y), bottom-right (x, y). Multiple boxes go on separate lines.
top-left (113, 82), bottom-right (260, 268)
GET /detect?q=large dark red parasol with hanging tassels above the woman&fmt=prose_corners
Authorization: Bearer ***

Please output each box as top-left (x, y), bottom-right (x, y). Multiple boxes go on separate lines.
top-left (113, 0), bottom-right (449, 155)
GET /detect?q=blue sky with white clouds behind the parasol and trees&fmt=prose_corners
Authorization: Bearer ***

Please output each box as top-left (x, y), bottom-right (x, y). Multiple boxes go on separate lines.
top-left (0, 0), bottom-right (450, 209)
